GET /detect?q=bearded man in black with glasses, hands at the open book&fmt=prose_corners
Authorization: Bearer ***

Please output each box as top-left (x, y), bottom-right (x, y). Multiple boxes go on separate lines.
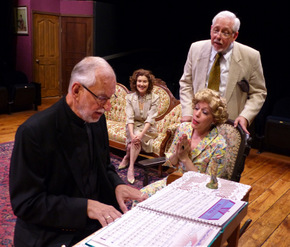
top-left (9, 57), bottom-right (144, 247)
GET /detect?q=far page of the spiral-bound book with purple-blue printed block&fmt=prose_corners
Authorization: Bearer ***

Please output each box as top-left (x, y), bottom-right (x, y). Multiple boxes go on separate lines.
top-left (137, 186), bottom-right (246, 227)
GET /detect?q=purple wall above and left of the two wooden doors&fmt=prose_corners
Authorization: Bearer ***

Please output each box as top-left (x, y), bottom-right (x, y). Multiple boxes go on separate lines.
top-left (16, 0), bottom-right (93, 81)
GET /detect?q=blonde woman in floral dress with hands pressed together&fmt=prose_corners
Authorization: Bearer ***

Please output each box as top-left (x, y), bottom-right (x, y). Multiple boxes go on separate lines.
top-left (137, 88), bottom-right (228, 196)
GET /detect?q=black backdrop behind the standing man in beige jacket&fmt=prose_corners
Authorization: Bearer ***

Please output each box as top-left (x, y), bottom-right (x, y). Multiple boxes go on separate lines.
top-left (95, 0), bottom-right (290, 143)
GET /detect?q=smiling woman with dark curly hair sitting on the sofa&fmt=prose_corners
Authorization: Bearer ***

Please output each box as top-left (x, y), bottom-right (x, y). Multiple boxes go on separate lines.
top-left (119, 69), bottom-right (159, 184)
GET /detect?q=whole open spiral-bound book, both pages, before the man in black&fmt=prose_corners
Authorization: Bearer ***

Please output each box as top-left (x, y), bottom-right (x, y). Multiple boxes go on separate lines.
top-left (81, 172), bottom-right (247, 247)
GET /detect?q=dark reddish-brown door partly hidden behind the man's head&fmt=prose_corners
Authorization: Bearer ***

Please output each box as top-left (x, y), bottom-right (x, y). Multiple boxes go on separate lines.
top-left (61, 16), bottom-right (93, 95)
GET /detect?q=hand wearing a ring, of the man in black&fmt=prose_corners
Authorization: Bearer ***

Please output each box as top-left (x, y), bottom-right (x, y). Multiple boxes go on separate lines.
top-left (87, 199), bottom-right (122, 227)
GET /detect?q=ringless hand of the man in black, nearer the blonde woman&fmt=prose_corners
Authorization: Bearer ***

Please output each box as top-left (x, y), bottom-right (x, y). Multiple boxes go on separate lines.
top-left (115, 184), bottom-right (148, 213)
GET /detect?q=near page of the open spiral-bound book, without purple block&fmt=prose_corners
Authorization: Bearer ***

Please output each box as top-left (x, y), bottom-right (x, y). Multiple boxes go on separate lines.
top-left (85, 206), bottom-right (220, 247)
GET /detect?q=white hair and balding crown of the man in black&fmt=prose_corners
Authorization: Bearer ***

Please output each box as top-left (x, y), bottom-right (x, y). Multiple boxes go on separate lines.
top-left (68, 56), bottom-right (115, 92)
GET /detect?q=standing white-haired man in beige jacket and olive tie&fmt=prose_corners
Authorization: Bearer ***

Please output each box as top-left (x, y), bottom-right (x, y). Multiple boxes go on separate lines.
top-left (179, 11), bottom-right (267, 133)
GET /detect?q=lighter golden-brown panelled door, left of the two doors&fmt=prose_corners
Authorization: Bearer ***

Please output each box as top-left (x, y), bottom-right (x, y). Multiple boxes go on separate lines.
top-left (33, 13), bottom-right (61, 97)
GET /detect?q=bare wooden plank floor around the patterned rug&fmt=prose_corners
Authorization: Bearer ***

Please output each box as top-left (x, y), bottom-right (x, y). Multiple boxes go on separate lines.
top-left (0, 98), bottom-right (290, 247)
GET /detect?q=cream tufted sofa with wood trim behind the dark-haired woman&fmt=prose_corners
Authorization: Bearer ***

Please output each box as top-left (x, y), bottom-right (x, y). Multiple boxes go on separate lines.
top-left (105, 80), bottom-right (181, 157)
